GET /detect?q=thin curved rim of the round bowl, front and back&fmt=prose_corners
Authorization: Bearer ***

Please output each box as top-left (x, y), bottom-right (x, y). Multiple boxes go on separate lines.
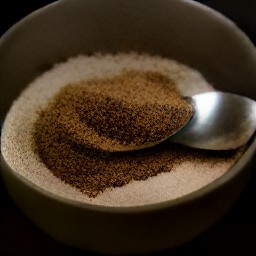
top-left (0, 0), bottom-right (256, 214)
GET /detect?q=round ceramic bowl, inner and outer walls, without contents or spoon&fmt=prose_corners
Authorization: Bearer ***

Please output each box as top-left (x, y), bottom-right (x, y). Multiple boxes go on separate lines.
top-left (0, 0), bottom-right (256, 254)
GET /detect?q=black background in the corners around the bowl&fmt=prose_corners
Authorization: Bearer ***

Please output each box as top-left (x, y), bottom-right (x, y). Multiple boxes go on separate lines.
top-left (0, 0), bottom-right (256, 256)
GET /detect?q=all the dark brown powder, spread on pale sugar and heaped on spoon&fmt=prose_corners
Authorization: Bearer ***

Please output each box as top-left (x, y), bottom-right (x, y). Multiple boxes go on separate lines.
top-left (33, 71), bottom-right (240, 197)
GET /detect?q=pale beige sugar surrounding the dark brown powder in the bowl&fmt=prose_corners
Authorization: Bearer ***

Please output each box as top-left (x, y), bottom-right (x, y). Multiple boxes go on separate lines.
top-left (1, 53), bottom-right (242, 206)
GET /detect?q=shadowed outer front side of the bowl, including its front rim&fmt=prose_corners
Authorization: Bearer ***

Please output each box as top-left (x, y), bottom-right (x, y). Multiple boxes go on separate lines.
top-left (1, 150), bottom-right (255, 254)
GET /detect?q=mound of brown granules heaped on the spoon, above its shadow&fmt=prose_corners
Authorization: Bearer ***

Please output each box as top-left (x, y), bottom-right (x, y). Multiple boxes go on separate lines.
top-left (40, 71), bottom-right (192, 152)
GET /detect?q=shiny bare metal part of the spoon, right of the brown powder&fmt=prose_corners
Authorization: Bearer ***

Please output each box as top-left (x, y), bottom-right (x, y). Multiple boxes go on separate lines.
top-left (166, 92), bottom-right (256, 150)
